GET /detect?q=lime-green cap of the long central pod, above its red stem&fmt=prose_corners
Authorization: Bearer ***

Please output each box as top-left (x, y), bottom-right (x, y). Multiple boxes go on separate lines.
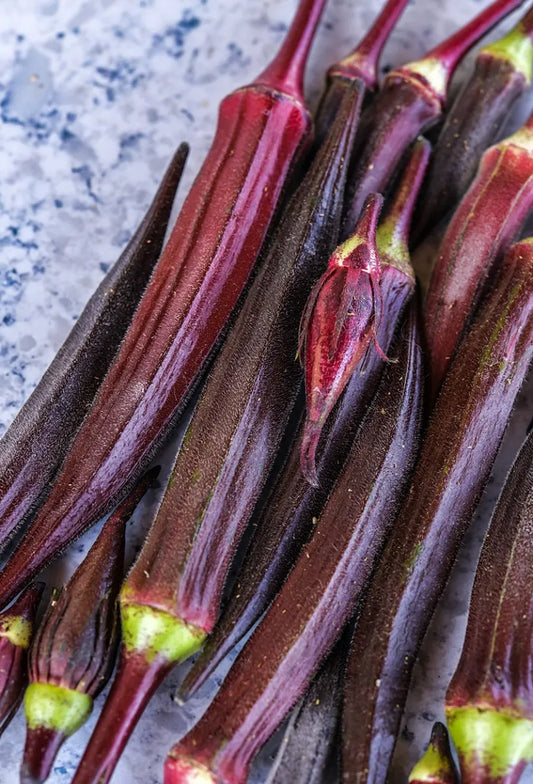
top-left (120, 601), bottom-right (207, 664)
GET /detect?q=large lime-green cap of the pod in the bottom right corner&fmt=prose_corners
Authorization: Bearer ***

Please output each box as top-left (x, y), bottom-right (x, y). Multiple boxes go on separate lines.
top-left (446, 706), bottom-right (533, 780)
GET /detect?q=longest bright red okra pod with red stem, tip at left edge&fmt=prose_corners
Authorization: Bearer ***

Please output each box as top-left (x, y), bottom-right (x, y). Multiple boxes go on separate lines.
top-left (0, 0), bottom-right (325, 606)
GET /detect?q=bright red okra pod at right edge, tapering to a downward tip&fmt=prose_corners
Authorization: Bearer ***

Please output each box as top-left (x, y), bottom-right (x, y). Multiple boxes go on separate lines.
top-left (424, 115), bottom-right (533, 399)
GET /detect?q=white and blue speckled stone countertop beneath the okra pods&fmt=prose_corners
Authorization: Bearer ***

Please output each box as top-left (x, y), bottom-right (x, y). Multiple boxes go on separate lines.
top-left (0, 0), bottom-right (533, 784)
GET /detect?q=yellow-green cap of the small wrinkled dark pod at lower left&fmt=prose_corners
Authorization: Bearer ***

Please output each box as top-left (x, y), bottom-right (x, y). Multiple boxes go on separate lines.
top-left (24, 683), bottom-right (93, 737)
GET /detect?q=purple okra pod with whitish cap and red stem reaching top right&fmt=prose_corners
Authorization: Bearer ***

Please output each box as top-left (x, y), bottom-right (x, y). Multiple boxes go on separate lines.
top-left (341, 0), bottom-right (523, 239)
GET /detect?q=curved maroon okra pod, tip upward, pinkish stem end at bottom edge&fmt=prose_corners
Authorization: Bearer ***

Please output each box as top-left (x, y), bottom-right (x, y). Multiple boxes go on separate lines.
top-left (164, 309), bottom-right (423, 784)
